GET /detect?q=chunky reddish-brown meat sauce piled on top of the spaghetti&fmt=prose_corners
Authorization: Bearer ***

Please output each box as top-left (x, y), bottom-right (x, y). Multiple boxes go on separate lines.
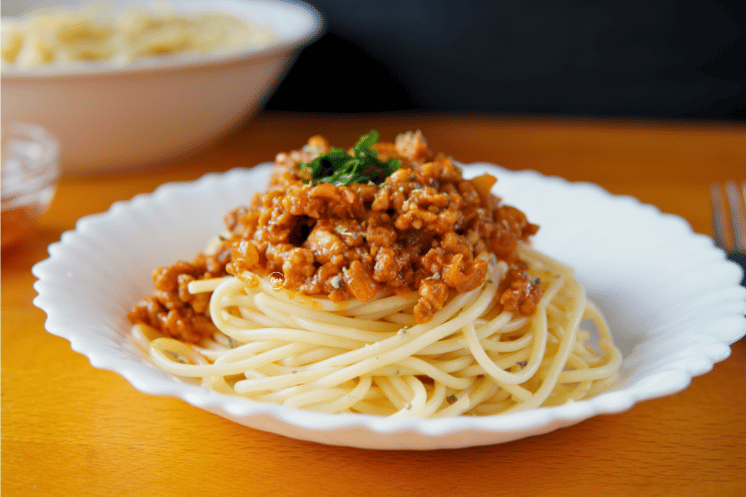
top-left (129, 132), bottom-right (541, 342)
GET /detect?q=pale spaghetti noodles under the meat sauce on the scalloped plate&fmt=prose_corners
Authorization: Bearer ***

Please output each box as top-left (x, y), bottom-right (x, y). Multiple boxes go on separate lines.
top-left (130, 130), bottom-right (621, 418)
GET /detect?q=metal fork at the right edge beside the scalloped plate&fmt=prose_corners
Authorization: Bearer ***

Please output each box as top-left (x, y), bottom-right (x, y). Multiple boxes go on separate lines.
top-left (710, 181), bottom-right (746, 286)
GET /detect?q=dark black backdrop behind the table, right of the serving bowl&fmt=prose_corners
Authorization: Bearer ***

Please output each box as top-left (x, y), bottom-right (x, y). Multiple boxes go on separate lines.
top-left (266, 0), bottom-right (746, 120)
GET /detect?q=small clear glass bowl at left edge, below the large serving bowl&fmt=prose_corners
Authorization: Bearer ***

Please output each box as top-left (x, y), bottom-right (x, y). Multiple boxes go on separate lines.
top-left (1, 123), bottom-right (59, 248)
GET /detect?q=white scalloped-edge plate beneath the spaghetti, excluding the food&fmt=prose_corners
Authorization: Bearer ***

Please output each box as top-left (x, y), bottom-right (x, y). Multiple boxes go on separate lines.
top-left (33, 164), bottom-right (746, 449)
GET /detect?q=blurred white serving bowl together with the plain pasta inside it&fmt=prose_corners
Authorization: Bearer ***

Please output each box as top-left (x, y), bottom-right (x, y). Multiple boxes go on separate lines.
top-left (2, 0), bottom-right (322, 174)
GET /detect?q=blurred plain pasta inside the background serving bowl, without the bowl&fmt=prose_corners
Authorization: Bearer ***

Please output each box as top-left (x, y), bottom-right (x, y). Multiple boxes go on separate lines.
top-left (2, 4), bottom-right (276, 68)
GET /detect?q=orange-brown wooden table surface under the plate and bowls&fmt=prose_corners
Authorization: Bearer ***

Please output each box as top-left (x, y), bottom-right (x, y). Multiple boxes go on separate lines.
top-left (2, 114), bottom-right (746, 497)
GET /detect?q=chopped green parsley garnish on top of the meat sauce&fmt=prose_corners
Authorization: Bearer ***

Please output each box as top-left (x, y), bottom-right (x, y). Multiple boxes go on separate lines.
top-left (300, 130), bottom-right (401, 186)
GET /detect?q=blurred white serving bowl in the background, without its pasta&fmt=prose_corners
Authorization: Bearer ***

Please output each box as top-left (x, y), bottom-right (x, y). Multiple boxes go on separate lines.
top-left (1, 0), bottom-right (322, 173)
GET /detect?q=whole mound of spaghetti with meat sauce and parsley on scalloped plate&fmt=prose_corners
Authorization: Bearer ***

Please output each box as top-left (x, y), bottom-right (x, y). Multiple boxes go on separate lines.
top-left (129, 132), bottom-right (622, 418)
